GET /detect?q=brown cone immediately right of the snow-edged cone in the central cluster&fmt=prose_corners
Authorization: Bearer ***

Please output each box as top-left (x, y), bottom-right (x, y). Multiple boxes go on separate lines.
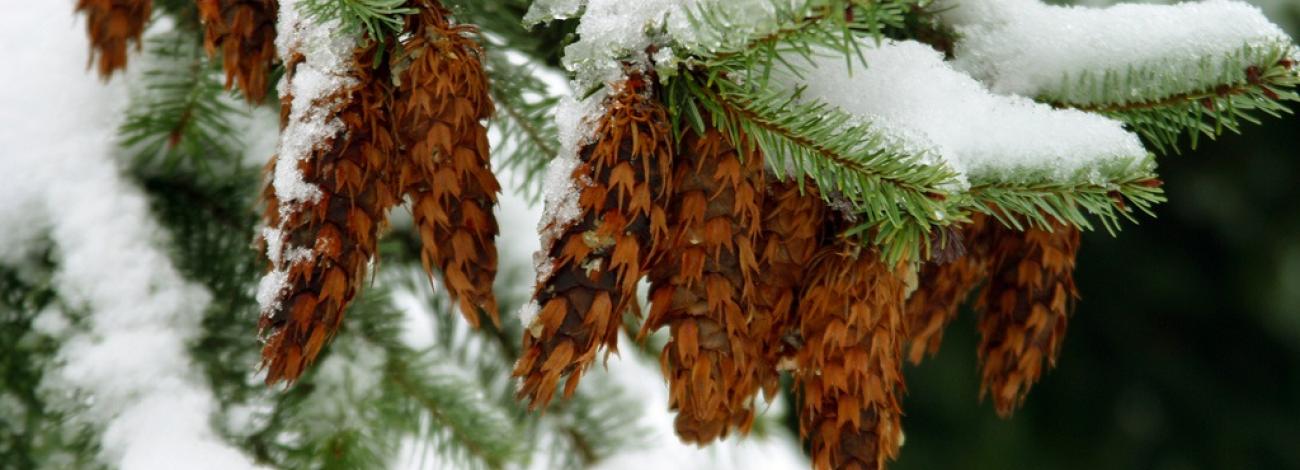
top-left (642, 129), bottom-right (764, 444)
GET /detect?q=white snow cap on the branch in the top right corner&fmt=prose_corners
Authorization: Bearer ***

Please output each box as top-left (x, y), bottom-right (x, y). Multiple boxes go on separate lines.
top-left (941, 0), bottom-right (1291, 103)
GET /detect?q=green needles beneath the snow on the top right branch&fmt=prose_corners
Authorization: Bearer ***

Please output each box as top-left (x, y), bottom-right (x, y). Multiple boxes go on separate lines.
top-left (1040, 44), bottom-right (1300, 153)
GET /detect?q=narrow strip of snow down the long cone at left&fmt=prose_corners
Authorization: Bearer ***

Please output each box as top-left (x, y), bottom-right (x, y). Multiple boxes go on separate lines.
top-left (257, 0), bottom-right (356, 313)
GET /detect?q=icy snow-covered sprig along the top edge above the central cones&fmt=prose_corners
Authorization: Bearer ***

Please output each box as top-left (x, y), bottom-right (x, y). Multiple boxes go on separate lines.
top-left (559, 0), bottom-right (919, 90)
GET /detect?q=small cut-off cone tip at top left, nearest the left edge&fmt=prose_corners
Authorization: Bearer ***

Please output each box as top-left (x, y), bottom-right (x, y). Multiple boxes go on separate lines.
top-left (77, 0), bottom-right (153, 79)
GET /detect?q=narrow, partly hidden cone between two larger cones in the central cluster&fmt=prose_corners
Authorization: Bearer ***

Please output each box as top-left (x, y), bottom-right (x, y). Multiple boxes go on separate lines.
top-left (750, 182), bottom-right (827, 400)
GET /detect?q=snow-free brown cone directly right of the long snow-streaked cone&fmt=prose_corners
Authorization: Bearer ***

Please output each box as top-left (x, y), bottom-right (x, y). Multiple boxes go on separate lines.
top-left (394, 1), bottom-right (501, 327)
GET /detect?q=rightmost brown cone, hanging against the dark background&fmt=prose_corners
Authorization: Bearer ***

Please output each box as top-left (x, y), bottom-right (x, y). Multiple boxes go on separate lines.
top-left (979, 223), bottom-right (1079, 418)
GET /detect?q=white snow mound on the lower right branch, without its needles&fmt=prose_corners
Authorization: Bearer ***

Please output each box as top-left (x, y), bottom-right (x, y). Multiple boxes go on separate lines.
top-left (774, 40), bottom-right (1147, 180)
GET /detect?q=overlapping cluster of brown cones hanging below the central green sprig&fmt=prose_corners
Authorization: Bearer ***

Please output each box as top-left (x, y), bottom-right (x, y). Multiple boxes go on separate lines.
top-left (515, 74), bottom-right (1079, 469)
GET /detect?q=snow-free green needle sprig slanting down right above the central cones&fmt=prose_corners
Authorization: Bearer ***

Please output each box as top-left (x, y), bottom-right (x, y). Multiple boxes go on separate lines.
top-left (670, 70), bottom-right (954, 260)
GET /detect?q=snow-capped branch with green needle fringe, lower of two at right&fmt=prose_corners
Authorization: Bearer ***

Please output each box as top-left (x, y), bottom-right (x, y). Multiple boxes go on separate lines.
top-left (750, 40), bottom-right (1162, 231)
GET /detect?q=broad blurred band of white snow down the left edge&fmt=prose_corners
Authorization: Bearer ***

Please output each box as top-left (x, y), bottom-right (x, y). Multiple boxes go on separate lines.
top-left (0, 0), bottom-right (261, 470)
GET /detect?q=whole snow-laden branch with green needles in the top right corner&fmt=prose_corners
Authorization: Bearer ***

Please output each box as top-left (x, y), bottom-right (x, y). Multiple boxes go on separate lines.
top-left (940, 0), bottom-right (1300, 151)
